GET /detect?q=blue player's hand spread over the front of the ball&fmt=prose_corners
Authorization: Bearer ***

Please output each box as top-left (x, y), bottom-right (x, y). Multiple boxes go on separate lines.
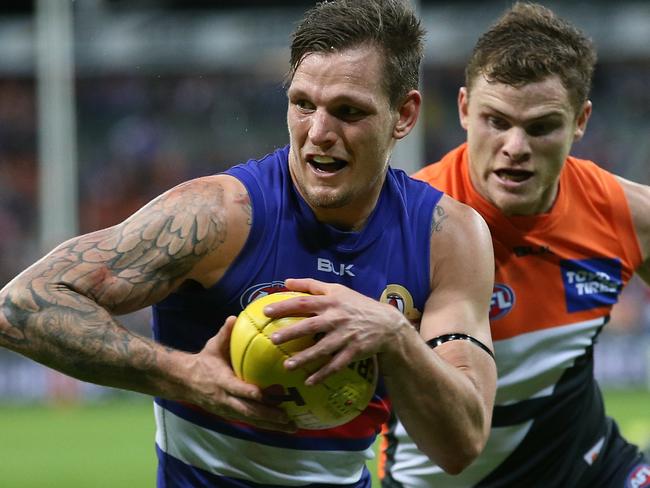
top-left (264, 278), bottom-right (404, 384)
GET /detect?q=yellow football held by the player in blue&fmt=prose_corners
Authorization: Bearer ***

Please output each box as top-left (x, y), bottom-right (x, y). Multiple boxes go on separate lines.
top-left (230, 292), bottom-right (378, 429)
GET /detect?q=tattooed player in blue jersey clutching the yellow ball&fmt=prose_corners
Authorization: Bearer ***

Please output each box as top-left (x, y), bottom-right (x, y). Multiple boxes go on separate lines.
top-left (0, 0), bottom-right (496, 487)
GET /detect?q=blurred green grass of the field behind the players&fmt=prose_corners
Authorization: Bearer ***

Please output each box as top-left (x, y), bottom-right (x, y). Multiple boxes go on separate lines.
top-left (0, 390), bottom-right (650, 488)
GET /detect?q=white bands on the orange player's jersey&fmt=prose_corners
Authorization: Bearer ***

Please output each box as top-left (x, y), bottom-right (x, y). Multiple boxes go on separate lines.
top-left (390, 317), bottom-right (606, 488)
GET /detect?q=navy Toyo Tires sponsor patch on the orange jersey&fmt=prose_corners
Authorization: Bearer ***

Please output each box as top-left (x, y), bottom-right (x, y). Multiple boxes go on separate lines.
top-left (560, 258), bottom-right (623, 312)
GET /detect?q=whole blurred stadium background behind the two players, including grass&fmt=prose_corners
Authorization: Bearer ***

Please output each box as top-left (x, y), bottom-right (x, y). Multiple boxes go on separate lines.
top-left (0, 0), bottom-right (650, 486)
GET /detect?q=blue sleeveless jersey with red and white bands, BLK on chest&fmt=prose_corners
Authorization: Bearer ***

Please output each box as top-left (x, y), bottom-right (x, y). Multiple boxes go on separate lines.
top-left (153, 147), bottom-right (442, 487)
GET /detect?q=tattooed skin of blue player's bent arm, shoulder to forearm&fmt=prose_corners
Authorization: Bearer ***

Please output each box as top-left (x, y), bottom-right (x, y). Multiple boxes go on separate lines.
top-left (0, 180), bottom-right (227, 390)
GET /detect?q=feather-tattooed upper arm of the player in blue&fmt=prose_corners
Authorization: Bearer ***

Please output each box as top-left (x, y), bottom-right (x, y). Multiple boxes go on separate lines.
top-left (26, 179), bottom-right (227, 312)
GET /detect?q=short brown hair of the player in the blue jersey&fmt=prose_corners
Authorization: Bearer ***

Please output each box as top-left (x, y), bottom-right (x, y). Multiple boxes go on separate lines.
top-left (287, 0), bottom-right (424, 106)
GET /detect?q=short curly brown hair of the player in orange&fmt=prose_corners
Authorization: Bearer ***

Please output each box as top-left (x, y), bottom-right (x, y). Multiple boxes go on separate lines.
top-left (465, 2), bottom-right (596, 113)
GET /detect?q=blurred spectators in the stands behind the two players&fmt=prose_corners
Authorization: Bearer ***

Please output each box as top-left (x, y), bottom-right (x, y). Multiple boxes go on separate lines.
top-left (0, 60), bottom-right (650, 400)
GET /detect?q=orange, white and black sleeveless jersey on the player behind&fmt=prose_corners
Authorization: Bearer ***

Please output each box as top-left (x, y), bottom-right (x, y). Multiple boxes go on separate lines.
top-left (381, 145), bottom-right (641, 488)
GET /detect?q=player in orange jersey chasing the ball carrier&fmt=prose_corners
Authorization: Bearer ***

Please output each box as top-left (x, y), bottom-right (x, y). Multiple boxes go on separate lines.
top-left (380, 3), bottom-right (650, 488)
